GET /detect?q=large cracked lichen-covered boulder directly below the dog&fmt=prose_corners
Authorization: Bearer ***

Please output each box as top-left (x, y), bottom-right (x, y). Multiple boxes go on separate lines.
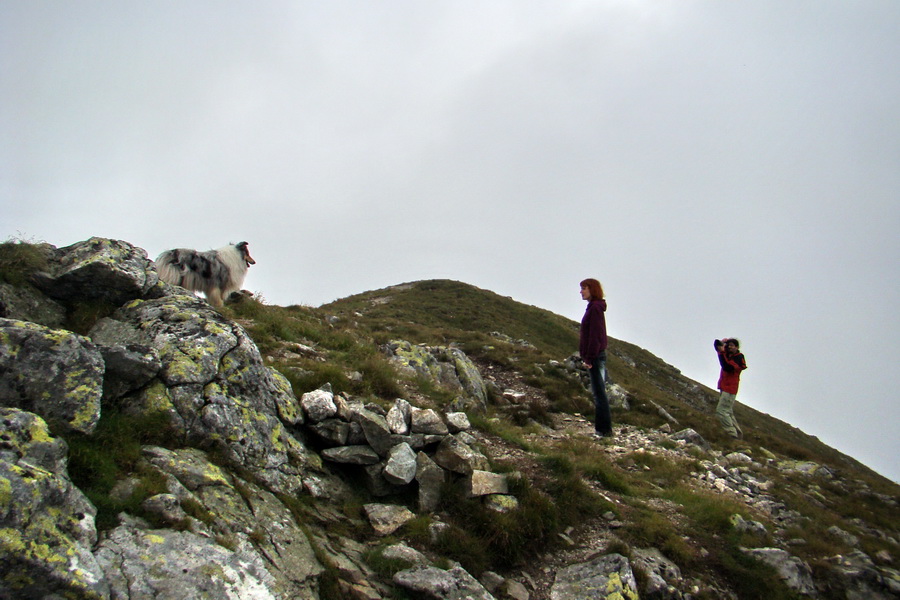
top-left (98, 295), bottom-right (320, 493)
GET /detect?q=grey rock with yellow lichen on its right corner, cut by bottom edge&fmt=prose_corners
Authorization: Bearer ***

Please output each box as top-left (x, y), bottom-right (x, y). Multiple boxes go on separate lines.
top-left (550, 554), bottom-right (637, 600)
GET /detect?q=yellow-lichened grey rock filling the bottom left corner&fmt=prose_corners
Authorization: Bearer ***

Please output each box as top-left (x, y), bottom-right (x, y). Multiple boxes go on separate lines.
top-left (0, 408), bottom-right (109, 599)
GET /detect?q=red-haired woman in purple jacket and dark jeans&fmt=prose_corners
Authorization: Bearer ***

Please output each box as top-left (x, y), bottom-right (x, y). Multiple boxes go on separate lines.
top-left (578, 279), bottom-right (612, 437)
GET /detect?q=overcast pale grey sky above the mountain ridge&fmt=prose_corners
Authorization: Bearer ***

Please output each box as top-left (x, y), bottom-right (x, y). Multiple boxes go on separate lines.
top-left (0, 0), bottom-right (900, 481)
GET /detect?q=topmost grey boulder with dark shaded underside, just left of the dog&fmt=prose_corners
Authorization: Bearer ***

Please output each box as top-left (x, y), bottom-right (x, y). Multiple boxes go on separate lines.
top-left (35, 237), bottom-right (159, 306)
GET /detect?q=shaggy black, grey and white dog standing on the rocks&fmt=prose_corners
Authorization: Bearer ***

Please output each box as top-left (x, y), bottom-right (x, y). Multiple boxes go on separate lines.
top-left (156, 242), bottom-right (256, 306)
